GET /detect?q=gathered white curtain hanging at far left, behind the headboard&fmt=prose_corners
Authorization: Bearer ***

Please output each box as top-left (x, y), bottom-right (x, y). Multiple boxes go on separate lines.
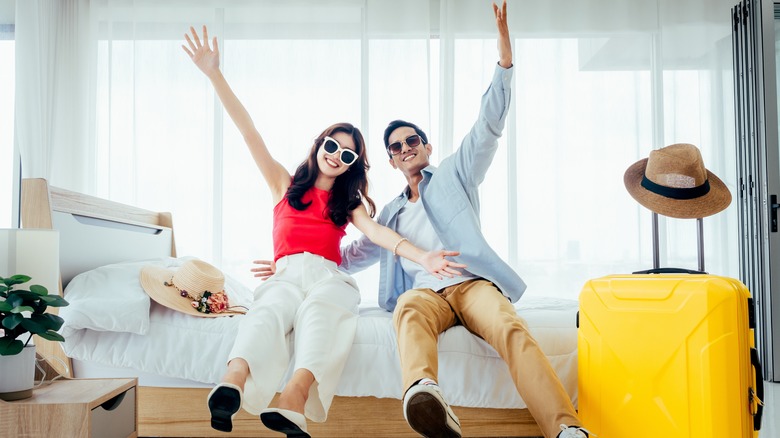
top-left (15, 0), bottom-right (95, 190)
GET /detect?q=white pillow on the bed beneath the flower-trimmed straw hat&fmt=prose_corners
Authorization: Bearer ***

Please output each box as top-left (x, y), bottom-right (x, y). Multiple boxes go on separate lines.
top-left (59, 257), bottom-right (252, 339)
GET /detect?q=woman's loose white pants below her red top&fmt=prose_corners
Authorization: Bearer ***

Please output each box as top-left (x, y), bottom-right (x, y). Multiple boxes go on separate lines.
top-left (228, 253), bottom-right (360, 422)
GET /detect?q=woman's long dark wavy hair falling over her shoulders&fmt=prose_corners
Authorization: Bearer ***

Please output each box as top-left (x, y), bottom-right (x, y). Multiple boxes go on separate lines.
top-left (285, 123), bottom-right (376, 226)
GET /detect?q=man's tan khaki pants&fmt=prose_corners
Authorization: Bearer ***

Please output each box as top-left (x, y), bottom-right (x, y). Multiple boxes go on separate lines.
top-left (393, 279), bottom-right (581, 438)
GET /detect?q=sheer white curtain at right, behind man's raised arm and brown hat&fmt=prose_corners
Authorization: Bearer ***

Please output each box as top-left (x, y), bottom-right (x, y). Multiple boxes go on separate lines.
top-left (441, 0), bottom-right (738, 298)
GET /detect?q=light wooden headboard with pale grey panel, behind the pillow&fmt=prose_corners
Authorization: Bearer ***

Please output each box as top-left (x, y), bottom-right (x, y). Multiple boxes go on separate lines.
top-left (21, 178), bottom-right (176, 377)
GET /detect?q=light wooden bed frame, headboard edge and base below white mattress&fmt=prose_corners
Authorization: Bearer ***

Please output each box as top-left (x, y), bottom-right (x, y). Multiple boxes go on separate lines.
top-left (22, 179), bottom-right (542, 438)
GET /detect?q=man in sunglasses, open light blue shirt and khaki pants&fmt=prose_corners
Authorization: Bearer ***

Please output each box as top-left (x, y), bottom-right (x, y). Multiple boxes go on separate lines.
top-left (340, 0), bottom-right (588, 438)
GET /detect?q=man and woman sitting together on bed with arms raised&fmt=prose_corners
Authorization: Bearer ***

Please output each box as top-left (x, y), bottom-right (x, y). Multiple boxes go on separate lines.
top-left (183, 2), bottom-right (587, 438)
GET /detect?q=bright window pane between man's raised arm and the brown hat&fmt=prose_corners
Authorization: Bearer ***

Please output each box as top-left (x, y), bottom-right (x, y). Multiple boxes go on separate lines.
top-left (514, 38), bottom-right (652, 298)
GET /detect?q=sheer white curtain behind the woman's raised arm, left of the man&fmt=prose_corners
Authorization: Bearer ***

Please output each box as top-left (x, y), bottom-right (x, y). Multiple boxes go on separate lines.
top-left (84, 0), bottom-right (431, 302)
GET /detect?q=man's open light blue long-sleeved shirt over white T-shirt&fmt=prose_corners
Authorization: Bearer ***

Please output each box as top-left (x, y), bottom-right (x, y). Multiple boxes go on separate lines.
top-left (339, 65), bottom-right (526, 312)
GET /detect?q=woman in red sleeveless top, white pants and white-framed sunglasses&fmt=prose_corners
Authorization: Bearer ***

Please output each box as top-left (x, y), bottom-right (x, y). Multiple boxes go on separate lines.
top-left (182, 26), bottom-right (465, 437)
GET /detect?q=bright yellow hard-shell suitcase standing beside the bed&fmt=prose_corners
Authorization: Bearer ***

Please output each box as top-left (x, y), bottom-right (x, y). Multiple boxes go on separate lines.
top-left (577, 274), bottom-right (763, 438)
